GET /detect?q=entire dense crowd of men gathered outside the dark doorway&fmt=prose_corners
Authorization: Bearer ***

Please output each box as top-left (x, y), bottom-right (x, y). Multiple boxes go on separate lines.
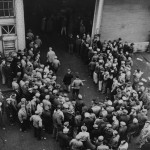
top-left (0, 27), bottom-right (150, 150)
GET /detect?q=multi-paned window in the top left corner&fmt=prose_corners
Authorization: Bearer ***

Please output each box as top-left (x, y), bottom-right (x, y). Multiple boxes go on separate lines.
top-left (0, 0), bottom-right (14, 17)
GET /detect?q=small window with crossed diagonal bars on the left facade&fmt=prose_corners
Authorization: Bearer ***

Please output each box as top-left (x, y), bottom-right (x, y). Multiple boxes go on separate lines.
top-left (2, 25), bottom-right (16, 35)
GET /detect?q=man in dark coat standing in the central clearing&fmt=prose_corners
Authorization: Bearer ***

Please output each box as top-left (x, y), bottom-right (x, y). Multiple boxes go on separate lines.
top-left (63, 69), bottom-right (73, 92)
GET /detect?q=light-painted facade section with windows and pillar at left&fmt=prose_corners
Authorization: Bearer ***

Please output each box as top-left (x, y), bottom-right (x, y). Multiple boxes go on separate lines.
top-left (0, 0), bottom-right (25, 56)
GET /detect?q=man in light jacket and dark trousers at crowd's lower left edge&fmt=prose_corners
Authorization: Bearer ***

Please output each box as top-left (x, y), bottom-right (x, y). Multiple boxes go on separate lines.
top-left (30, 111), bottom-right (43, 140)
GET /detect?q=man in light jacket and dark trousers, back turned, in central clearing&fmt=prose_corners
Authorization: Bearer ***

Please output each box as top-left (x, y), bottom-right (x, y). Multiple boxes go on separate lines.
top-left (72, 75), bottom-right (83, 99)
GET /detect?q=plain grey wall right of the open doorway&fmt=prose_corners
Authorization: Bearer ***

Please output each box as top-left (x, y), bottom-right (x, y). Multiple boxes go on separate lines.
top-left (101, 0), bottom-right (150, 42)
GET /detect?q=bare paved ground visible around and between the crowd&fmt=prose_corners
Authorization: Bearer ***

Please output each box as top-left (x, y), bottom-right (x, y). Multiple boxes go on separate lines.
top-left (0, 35), bottom-right (150, 150)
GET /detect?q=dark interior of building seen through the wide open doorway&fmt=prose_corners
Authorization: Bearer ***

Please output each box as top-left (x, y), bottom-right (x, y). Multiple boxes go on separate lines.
top-left (24, 0), bottom-right (95, 34)
